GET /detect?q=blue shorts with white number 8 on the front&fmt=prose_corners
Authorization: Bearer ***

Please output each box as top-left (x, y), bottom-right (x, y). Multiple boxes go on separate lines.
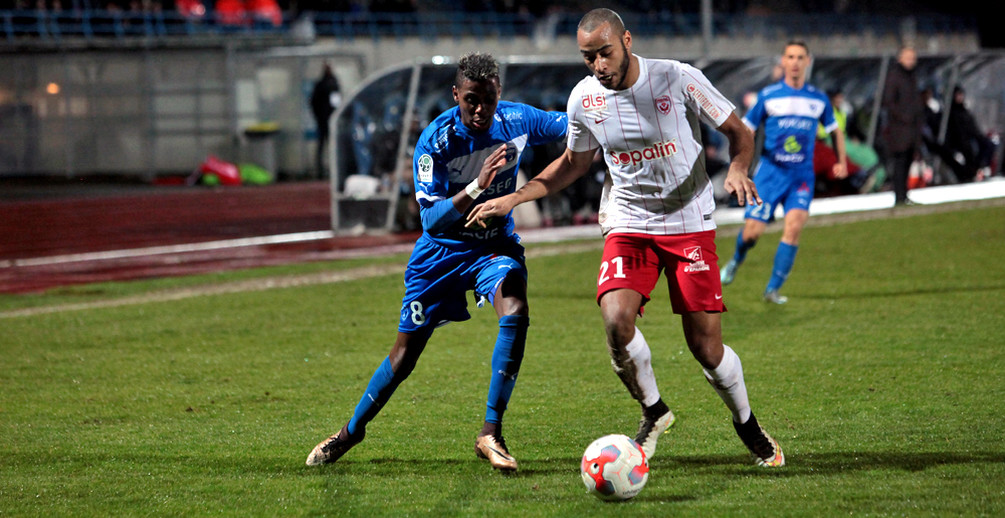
top-left (398, 234), bottom-right (527, 333)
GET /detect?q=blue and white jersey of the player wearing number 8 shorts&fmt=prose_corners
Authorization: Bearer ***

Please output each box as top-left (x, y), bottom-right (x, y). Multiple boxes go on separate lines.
top-left (412, 101), bottom-right (569, 248)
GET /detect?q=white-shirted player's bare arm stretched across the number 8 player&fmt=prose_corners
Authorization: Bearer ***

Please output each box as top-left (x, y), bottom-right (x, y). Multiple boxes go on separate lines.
top-left (464, 148), bottom-right (596, 227)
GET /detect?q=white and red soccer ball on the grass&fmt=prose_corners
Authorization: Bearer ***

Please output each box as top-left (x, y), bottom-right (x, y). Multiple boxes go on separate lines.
top-left (580, 434), bottom-right (649, 500)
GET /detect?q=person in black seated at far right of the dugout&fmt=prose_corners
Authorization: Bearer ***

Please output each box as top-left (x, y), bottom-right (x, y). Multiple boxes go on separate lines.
top-left (946, 87), bottom-right (995, 182)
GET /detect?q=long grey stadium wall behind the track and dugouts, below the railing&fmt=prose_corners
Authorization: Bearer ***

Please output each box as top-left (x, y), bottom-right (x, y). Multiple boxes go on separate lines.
top-left (0, 27), bottom-right (978, 180)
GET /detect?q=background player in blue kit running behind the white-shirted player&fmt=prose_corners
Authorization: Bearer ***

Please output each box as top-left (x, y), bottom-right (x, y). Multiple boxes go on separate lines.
top-left (721, 41), bottom-right (847, 304)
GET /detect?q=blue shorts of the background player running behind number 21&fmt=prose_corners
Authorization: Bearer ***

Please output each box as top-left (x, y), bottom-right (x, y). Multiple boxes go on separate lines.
top-left (744, 159), bottom-right (815, 223)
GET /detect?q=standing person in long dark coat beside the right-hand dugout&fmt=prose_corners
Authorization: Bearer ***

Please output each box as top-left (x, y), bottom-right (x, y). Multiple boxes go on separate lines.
top-left (881, 46), bottom-right (925, 205)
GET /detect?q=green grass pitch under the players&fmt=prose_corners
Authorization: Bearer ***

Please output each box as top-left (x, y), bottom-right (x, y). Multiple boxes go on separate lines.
top-left (0, 204), bottom-right (1005, 517)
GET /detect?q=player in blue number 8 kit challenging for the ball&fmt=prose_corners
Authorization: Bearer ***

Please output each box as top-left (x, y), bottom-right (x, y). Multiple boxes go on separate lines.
top-left (307, 53), bottom-right (568, 471)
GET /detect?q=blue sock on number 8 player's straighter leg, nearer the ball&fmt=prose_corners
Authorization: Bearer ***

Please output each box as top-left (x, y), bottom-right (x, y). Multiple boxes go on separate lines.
top-left (485, 315), bottom-right (531, 423)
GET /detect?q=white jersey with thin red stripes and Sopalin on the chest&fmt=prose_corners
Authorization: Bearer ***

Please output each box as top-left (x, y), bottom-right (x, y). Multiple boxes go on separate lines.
top-left (567, 56), bottom-right (736, 235)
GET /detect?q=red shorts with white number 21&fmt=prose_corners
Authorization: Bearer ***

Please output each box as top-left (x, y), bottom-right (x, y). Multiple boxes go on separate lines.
top-left (597, 230), bottom-right (726, 314)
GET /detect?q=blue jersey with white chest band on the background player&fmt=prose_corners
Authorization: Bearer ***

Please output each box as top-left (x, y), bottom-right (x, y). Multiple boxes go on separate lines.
top-left (743, 79), bottom-right (837, 174)
